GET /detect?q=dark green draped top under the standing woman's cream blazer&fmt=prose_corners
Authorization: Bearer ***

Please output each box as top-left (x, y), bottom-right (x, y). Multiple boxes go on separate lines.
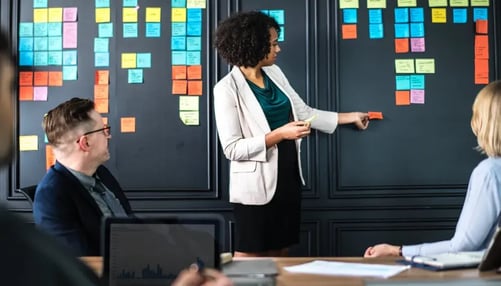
top-left (247, 71), bottom-right (291, 130)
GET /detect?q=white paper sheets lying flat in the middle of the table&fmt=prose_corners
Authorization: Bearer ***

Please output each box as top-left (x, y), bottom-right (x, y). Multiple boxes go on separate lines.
top-left (284, 260), bottom-right (410, 278)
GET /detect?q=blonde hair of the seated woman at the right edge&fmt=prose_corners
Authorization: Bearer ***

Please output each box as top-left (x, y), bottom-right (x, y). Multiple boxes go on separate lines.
top-left (471, 80), bottom-right (501, 157)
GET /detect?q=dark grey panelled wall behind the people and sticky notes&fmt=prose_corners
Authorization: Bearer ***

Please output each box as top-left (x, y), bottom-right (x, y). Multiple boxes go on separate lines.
top-left (0, 0), bottom-right (501, 256)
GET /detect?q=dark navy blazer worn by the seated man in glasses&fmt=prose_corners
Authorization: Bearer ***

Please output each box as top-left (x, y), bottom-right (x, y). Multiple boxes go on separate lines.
top-left (33, 162), bottom-right (132, 256)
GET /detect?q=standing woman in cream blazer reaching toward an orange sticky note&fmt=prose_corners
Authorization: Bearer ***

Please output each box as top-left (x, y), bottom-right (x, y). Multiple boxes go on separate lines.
top-left (214, 12), bottom-right (369, 256)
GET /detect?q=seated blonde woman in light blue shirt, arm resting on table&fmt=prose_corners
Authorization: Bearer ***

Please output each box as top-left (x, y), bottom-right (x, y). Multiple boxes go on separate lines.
top-left (364, 80), bottom-right (501, 257)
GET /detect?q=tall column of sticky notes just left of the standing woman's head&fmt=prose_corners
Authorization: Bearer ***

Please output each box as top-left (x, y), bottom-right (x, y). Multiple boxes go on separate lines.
top-left (171, 0), bottom-right (206, 125)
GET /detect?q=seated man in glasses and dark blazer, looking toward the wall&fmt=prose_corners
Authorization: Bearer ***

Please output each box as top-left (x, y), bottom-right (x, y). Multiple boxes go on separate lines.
top-left (33, 98), bottom-right (131, 256)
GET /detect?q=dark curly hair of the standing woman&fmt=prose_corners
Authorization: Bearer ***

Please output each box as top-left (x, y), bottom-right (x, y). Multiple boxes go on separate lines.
top-left (214, 11), bottom-right (280, 67)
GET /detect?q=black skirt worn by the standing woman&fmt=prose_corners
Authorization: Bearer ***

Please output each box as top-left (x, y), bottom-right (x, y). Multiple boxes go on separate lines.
top-left (233, 140), bottom-right (301, 252)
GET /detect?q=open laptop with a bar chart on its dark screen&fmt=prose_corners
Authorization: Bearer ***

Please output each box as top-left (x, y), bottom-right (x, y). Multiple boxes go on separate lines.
top-left (102, 217), bottom-right (221, 286)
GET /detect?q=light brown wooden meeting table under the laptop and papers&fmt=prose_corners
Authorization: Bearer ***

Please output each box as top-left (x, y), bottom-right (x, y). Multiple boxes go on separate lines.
top-left (81, 256), bottom-right (501, 286)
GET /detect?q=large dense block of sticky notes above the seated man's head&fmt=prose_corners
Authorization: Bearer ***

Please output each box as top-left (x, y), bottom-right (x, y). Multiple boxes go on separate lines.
top-left (18, 0), bottom-right (78, 101)
